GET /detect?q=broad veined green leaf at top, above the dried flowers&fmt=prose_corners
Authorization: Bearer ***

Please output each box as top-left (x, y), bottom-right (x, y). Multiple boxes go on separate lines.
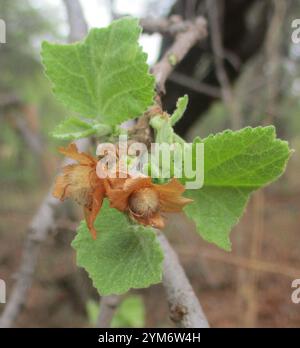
top-left (42, 18), bottom-right (154, 125)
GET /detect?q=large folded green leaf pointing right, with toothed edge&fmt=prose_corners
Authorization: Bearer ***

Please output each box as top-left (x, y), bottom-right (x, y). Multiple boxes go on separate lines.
top-left (185, 126), bottom-right (291, 250)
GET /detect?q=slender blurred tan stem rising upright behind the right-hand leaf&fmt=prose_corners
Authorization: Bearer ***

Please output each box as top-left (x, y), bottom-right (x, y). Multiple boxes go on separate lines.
top-left (240, 0), bottom-right (288, 327)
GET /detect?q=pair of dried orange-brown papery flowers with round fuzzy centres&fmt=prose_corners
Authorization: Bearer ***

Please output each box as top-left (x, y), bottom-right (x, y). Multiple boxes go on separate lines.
top-left (53, 144), bottom-right (191, 238)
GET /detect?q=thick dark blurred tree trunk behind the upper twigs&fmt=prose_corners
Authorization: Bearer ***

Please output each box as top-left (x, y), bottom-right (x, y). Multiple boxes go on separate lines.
top-left (161, 0), bottom-right (272, 135)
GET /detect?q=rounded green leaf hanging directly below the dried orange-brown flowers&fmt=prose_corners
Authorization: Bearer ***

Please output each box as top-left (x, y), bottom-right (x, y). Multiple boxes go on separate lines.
top-left (72, 201), bottom-right (163, 296)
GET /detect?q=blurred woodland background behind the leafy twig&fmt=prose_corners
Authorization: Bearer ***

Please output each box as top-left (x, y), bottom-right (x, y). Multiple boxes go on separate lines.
top-left (0, 0), bottom-right (300, 327)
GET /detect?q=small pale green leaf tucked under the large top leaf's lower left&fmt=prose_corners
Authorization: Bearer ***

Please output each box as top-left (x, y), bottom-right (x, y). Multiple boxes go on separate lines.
top-left (51, 117), bottom-right (112, 140)
